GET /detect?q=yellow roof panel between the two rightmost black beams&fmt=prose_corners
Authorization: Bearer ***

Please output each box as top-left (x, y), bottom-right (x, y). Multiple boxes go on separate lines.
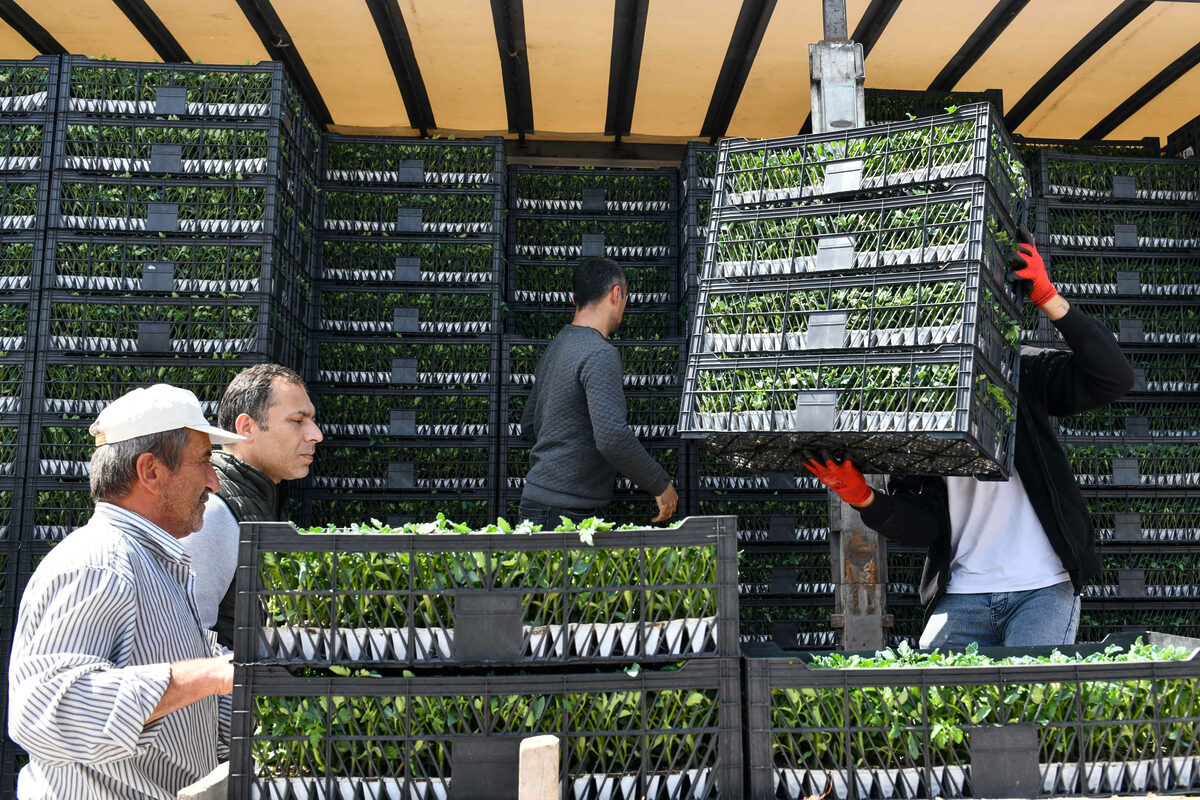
top-left (1021, 2), bottom-right (1200, 139)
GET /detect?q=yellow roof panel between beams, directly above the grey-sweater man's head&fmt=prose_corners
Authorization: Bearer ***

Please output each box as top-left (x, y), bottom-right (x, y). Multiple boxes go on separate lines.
top-left (524, 0), bottom-right (616, 134)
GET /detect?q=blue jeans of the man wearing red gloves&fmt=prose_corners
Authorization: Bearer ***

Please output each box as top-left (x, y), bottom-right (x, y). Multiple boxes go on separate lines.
top-left (920, 581), bottom-right (1079, 650)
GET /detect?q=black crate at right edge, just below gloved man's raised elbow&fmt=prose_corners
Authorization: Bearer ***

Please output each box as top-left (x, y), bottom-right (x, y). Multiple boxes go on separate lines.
top-left (1058, 397), bottom-right (1200, 443)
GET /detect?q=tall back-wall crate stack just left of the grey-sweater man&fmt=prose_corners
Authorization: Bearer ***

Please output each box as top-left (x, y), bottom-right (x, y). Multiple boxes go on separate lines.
top-left (300, 136), bottom-right (505, 525)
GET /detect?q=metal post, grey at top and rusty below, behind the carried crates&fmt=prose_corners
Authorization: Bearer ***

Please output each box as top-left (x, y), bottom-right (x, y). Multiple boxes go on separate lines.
top-left (809, 0), bottom-right (892, 650)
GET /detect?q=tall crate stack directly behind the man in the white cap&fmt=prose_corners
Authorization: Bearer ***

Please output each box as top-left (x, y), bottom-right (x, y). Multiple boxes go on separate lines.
top-left (23, 56), bottom-right (319, 575)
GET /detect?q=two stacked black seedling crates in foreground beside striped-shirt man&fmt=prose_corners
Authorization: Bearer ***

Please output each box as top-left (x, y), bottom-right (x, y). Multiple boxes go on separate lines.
top-left (229, 517), bottom-right (743, 800)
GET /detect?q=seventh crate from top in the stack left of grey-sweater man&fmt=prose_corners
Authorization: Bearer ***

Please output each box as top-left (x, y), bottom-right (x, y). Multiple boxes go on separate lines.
top-left (311, 438), bottom-right (496, 492)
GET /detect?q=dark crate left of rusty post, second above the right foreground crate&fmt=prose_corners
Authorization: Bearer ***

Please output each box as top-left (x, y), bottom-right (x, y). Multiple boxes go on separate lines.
top-left (738, 543), bottom-right (836, 603)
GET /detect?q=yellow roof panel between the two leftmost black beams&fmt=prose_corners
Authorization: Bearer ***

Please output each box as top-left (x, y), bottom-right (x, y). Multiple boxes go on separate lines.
top-left (17, 0), bottom-right (162, 61)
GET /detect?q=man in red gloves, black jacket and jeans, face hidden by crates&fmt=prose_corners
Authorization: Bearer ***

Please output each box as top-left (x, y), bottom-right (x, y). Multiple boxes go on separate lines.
top-left (806, 229), bottom-right (1134, 649)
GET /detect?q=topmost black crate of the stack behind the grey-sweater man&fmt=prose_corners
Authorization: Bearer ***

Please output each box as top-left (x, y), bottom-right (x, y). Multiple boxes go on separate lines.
top-left (509, 166), bottom-right (679, 215)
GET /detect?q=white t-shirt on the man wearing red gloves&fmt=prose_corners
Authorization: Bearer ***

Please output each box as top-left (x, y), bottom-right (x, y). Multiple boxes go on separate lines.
top-left (946, 471), bottom-right (1070, 595)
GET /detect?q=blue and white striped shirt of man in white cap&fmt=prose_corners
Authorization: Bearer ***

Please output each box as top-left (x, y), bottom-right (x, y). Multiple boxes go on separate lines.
top-left (8, 503), bottom-right (230, 800)
